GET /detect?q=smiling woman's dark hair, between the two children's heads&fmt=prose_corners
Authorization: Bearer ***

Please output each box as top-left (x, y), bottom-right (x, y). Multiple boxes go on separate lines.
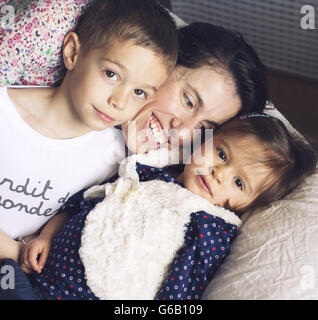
top-left (177, 23), bottom-right (268, 114)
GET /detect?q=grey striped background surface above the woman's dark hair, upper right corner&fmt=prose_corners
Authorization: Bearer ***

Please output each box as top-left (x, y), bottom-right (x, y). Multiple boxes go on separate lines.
top-left (171, 0), bottom-right (318, 80)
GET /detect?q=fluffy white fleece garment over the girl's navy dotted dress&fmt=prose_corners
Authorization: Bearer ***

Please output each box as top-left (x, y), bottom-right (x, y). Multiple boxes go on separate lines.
top-left (79, 149), bottom-right (240, 300)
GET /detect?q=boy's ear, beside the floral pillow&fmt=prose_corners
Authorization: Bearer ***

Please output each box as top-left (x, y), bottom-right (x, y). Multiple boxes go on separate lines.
top-left (63, 32), bottom-right (81, 71)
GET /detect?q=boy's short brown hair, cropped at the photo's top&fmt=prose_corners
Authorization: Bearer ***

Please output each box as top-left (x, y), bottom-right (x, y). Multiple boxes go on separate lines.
top-left (75, 0), bottom-right (178, 69)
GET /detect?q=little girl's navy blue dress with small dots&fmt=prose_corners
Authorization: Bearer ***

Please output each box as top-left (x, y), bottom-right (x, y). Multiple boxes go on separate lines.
top-left (34, 163), bottom-right (237, 300)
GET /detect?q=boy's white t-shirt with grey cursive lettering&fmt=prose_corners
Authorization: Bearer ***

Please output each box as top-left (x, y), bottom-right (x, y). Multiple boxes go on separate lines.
top-left (0, 87), bottom-right (125, 238)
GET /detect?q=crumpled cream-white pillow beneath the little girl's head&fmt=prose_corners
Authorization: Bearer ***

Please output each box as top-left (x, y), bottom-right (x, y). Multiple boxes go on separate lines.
top-left (203, 106), bottom-right (318, 300)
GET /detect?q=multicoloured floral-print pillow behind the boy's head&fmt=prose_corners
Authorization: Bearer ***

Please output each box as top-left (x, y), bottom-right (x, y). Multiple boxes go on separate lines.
top-left (0, 0), bottom-right (93, 86)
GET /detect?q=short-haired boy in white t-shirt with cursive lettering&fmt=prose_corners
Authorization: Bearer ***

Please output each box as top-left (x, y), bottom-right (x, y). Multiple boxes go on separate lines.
top-left (0, 0), bottom-right (177, 259)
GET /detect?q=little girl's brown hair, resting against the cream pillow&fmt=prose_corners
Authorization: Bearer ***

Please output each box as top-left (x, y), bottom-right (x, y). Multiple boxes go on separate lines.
top-left (221, 114), bottom-right (317, 211)
